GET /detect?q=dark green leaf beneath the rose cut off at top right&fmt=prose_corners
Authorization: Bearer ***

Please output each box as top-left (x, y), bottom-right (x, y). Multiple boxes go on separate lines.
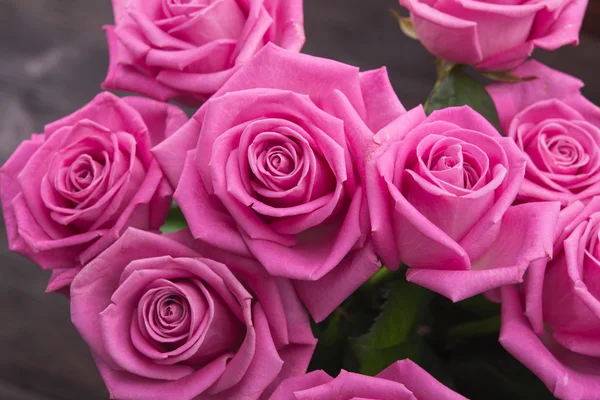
top-left (425, 68), bottom-right (501, 131)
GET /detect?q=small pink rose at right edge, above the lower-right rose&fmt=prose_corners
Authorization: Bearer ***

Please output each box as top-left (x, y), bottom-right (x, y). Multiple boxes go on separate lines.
top-left (488, 61), bottom-right (600, 206)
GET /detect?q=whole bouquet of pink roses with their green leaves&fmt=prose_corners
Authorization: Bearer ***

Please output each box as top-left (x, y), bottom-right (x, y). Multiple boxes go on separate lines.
top-left (0, 0), bottom-right (600, 400)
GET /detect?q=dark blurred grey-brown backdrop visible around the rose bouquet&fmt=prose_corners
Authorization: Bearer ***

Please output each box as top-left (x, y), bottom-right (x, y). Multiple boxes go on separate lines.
top-left (0, 0), bottom-right (600, 400)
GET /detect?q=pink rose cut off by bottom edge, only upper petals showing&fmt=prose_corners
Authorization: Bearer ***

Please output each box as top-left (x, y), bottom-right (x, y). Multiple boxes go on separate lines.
top-left (270, 360), bottom-right (466, 400)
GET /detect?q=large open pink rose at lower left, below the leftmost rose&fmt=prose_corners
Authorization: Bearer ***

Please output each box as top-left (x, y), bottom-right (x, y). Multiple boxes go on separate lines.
top-left (71, 229), bottom-right (316, 400)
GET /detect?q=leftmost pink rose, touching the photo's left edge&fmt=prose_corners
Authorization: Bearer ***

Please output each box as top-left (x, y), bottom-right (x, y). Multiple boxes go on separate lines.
top-left (0, 93), bottom-right (187, 291)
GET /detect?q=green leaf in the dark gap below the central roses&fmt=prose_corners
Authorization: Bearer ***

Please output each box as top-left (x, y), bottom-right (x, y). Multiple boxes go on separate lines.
top-left (352, 280), bottom-right (433, 375)
